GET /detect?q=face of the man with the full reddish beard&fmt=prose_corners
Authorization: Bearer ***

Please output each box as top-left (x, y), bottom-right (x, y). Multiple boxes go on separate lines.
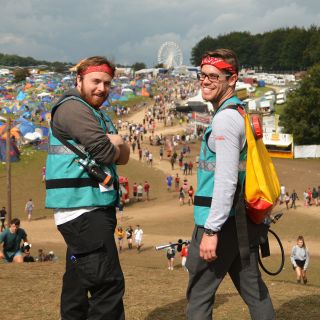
top-left (77, 72), bottom-right (112, 109)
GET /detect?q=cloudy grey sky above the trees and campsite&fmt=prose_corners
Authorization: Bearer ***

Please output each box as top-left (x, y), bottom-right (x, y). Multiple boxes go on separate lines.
top-left (0, 0), bottom-right (320, 66)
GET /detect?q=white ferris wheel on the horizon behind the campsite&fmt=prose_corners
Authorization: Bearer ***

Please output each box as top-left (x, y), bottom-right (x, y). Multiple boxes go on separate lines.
top-left (158, 41), bottom-right (183, 69)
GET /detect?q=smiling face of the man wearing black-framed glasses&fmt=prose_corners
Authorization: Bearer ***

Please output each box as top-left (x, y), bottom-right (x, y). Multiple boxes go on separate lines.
top-left (200, 64), bottom-right (237, 106)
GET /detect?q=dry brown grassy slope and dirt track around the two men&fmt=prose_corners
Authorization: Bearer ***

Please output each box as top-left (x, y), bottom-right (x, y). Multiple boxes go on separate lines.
top-left (0, 142), bottom-right (320, 320)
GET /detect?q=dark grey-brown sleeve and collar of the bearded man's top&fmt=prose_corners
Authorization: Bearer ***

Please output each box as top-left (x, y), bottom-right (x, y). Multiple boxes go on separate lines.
top-left (53, 89), bottom-right (116, 165)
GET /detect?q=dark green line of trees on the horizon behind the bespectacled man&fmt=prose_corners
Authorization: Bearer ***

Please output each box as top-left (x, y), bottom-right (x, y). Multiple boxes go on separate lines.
top-left (190, 25), bottom-right (320, 72)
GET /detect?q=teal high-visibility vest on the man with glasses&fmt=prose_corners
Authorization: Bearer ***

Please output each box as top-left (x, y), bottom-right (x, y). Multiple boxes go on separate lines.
top-left (194, 97), bottom-right (247, 226)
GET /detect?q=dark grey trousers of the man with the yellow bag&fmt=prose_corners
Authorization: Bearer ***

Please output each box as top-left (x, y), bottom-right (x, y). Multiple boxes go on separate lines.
top-left (186, 217), bottom-right (275, 320)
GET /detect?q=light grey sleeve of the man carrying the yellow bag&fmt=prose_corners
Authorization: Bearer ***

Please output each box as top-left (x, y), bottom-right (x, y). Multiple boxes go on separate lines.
top-left (205, 109), bottom-right (246, 231)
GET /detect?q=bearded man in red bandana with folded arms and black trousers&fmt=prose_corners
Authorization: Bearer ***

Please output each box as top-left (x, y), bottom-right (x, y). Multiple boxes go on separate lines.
top-left (46, 56), bottom-right (130, 320)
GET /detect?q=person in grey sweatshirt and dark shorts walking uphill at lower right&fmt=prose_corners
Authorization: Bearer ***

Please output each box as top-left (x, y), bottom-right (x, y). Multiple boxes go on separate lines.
top-left (290, 236), bottom-right (310, 284)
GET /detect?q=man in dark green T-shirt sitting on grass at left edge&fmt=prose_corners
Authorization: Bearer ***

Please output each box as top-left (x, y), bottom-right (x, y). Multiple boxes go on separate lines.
top-left (0, 218), bottom-right (28, 263)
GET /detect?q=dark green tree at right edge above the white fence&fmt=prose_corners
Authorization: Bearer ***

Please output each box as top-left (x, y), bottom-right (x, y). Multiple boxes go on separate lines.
top-left (280, 64), bottom-right (320, 145)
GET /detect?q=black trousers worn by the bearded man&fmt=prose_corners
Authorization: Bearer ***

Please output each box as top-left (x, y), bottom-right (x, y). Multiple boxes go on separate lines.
top-left (58, 207), bottom-right (125, 320)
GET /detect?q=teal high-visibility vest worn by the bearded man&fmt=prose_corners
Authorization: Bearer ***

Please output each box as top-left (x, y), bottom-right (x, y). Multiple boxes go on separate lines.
top-left (46, 96), bottom-right (118, 209)
